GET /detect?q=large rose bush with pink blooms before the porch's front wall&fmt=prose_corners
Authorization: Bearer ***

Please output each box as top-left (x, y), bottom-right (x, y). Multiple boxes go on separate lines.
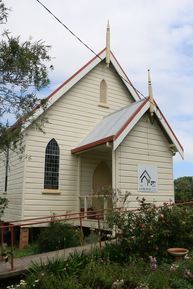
top-left (108, 199), bottom-right (193, 258)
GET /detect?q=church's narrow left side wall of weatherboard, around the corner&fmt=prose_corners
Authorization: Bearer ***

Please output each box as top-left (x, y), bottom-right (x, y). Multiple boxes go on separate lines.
top-left (0, 151), bottom-right (25, 221)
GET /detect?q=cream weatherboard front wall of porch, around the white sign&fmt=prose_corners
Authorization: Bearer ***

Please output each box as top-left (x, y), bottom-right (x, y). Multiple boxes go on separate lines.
top-left (116, 114), bottom-right (174, 208)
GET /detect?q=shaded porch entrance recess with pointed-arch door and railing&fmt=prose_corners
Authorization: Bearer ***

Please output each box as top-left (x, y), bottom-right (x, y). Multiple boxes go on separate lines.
top-left (77, 143), bottom-right (115, 220)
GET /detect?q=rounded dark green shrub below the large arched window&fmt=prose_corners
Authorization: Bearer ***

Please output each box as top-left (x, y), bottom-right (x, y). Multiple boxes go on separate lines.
top-left (37, 222), bottom-right (80, 252)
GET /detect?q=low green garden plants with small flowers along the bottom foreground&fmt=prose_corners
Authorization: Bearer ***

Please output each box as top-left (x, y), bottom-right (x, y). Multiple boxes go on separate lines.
top-left (10, 251), bottom-right (193, 289)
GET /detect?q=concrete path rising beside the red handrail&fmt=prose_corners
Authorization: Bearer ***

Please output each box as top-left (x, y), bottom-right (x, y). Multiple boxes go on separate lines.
top-left (0, 242), bottom-right (105, 279)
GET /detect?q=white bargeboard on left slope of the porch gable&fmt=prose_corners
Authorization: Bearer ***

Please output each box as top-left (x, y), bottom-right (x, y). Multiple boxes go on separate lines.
top-left (113, 101), bottom-right (150, 150)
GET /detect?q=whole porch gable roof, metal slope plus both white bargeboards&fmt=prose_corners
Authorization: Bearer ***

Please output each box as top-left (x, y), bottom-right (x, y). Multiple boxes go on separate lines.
top-left (71, 98), bottom-right (184, 158)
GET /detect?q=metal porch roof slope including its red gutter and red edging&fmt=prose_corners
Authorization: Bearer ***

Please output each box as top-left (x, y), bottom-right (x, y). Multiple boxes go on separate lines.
top-left (72, 98), bottom-right (149, 153)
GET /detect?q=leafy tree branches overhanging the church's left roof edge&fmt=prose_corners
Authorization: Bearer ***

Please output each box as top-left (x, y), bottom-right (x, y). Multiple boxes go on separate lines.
top-left (0, 0), bottom-right (53, 153)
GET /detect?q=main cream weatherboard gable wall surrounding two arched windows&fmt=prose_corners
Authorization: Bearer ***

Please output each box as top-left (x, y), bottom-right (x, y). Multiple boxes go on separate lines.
top-left (22, 63), bottom-right (133, 218)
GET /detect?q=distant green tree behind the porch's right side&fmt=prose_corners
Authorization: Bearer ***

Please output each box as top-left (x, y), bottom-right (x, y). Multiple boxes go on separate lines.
top-left (174, 177), bottom-right (193, 202)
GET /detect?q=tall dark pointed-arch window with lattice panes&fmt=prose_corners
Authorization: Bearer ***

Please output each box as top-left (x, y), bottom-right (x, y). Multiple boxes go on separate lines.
top-left (44, 138), bottom-right (60, 189)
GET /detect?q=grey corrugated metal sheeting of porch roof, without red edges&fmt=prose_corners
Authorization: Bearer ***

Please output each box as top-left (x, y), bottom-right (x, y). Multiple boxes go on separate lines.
top-left (74, 99), bottom-right (146, 148)
